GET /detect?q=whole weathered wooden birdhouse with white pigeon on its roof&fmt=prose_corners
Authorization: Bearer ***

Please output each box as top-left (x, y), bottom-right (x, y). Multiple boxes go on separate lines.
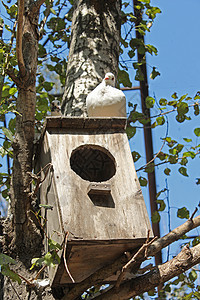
top-left (37, 117), bottom-right (152, 286)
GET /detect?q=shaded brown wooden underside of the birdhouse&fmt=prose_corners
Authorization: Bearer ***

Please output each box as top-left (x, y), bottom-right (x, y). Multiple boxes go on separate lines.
top-left (53, 239), bottom-right (145, 286)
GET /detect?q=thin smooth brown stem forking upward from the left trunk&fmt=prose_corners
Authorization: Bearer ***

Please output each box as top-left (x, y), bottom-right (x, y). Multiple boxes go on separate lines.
top-left (16, 0), bottom-right (26, 77)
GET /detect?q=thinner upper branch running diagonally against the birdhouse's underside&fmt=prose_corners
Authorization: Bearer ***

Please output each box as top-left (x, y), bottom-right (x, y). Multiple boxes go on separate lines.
top-left (63, 215), bottom-right (200, 300)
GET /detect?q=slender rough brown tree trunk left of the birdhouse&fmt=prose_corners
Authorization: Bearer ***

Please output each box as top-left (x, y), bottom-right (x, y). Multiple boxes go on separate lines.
top-left (2, 0), bottom-right (51, 300)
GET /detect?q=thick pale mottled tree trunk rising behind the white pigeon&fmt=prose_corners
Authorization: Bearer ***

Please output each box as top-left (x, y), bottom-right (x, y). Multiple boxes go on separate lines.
top-left (61, 0), bottom-right (121, 117)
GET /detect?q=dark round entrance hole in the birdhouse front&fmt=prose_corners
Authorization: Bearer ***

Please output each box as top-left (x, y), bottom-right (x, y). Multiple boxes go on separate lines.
top-left (70, 145), bottom-right (116, 182)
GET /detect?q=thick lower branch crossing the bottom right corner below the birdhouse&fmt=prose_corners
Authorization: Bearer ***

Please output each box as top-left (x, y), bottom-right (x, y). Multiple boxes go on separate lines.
top-left (93, 244), bottom-right (200, 300)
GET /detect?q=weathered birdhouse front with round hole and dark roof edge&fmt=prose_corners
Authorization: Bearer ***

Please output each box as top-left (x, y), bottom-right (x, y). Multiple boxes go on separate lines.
top-left (39, 118), bottom-right (151, 241)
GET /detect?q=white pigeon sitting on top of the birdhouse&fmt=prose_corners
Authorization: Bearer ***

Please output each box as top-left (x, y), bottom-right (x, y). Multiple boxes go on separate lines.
top-left (86, 73), bottom-right (126, 118)
